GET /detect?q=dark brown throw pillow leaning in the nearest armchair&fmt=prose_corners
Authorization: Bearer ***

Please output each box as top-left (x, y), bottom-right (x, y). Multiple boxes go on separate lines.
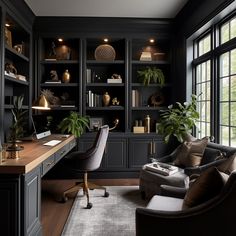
top-left (183, 167), bottom-right (229, 209)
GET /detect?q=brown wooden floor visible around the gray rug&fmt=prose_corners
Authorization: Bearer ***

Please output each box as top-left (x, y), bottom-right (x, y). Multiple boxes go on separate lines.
top-left (41, 179), bottom-right (139, 236)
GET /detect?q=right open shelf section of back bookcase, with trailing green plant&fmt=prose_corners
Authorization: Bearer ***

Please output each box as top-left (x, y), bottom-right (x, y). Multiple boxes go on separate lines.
top-left (129, 39), bottom-right (172, 132)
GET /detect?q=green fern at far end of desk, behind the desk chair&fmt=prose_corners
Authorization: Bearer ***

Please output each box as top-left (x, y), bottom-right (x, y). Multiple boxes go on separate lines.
top-left (58, 111), bottom-right (89, 138)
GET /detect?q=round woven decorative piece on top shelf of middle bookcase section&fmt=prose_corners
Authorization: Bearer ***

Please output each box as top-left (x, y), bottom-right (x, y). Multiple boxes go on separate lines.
top-left (94, 44), bottom-right (116, 61)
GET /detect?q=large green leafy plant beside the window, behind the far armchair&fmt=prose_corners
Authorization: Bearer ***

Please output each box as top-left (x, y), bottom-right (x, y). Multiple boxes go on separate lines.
top-left (158, 94), bottom-right (199, 143)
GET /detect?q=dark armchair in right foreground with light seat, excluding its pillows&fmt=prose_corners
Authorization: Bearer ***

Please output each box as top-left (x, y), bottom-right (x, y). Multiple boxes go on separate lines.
top-left (136, 171), bottom-right (236, 236)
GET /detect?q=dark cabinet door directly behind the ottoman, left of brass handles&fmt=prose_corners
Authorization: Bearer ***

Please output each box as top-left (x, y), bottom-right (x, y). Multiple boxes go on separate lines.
top-left (129, 138), bottom-right (153, 169)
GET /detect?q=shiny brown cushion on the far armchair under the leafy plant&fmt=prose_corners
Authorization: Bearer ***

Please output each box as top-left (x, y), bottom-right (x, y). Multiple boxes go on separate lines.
top-left (174, 137), bottom-right (209, 167)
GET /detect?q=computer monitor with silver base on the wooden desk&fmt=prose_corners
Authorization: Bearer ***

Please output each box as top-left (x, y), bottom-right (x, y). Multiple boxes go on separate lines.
top-left (31, 115), bottom-right (51, 139)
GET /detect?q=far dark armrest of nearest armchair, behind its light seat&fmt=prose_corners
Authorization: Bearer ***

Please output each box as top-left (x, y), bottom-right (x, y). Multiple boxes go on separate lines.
top-left (160, 184), bottom-right (187, 199)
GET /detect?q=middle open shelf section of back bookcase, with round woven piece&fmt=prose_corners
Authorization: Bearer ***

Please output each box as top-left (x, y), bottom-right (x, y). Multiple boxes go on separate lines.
top-left (84, 38), bottom-right (126, 132)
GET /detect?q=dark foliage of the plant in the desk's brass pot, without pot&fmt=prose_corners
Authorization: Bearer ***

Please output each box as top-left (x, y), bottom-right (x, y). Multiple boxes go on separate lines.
top-left (9, 96), bottom-right (27, 142)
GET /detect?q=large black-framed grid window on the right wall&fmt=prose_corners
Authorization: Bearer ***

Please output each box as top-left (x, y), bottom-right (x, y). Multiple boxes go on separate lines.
top-left (191, 10), bottom-right (236, 147)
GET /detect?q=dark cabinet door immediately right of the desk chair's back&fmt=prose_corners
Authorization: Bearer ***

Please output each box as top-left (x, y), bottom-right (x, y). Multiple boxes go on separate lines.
top-left (104, 139), bottom-right (127, 170)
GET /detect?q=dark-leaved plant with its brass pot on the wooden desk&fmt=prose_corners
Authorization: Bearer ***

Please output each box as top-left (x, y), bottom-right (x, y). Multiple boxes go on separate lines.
top-left (7, 95), bottom-right (27, 158)
